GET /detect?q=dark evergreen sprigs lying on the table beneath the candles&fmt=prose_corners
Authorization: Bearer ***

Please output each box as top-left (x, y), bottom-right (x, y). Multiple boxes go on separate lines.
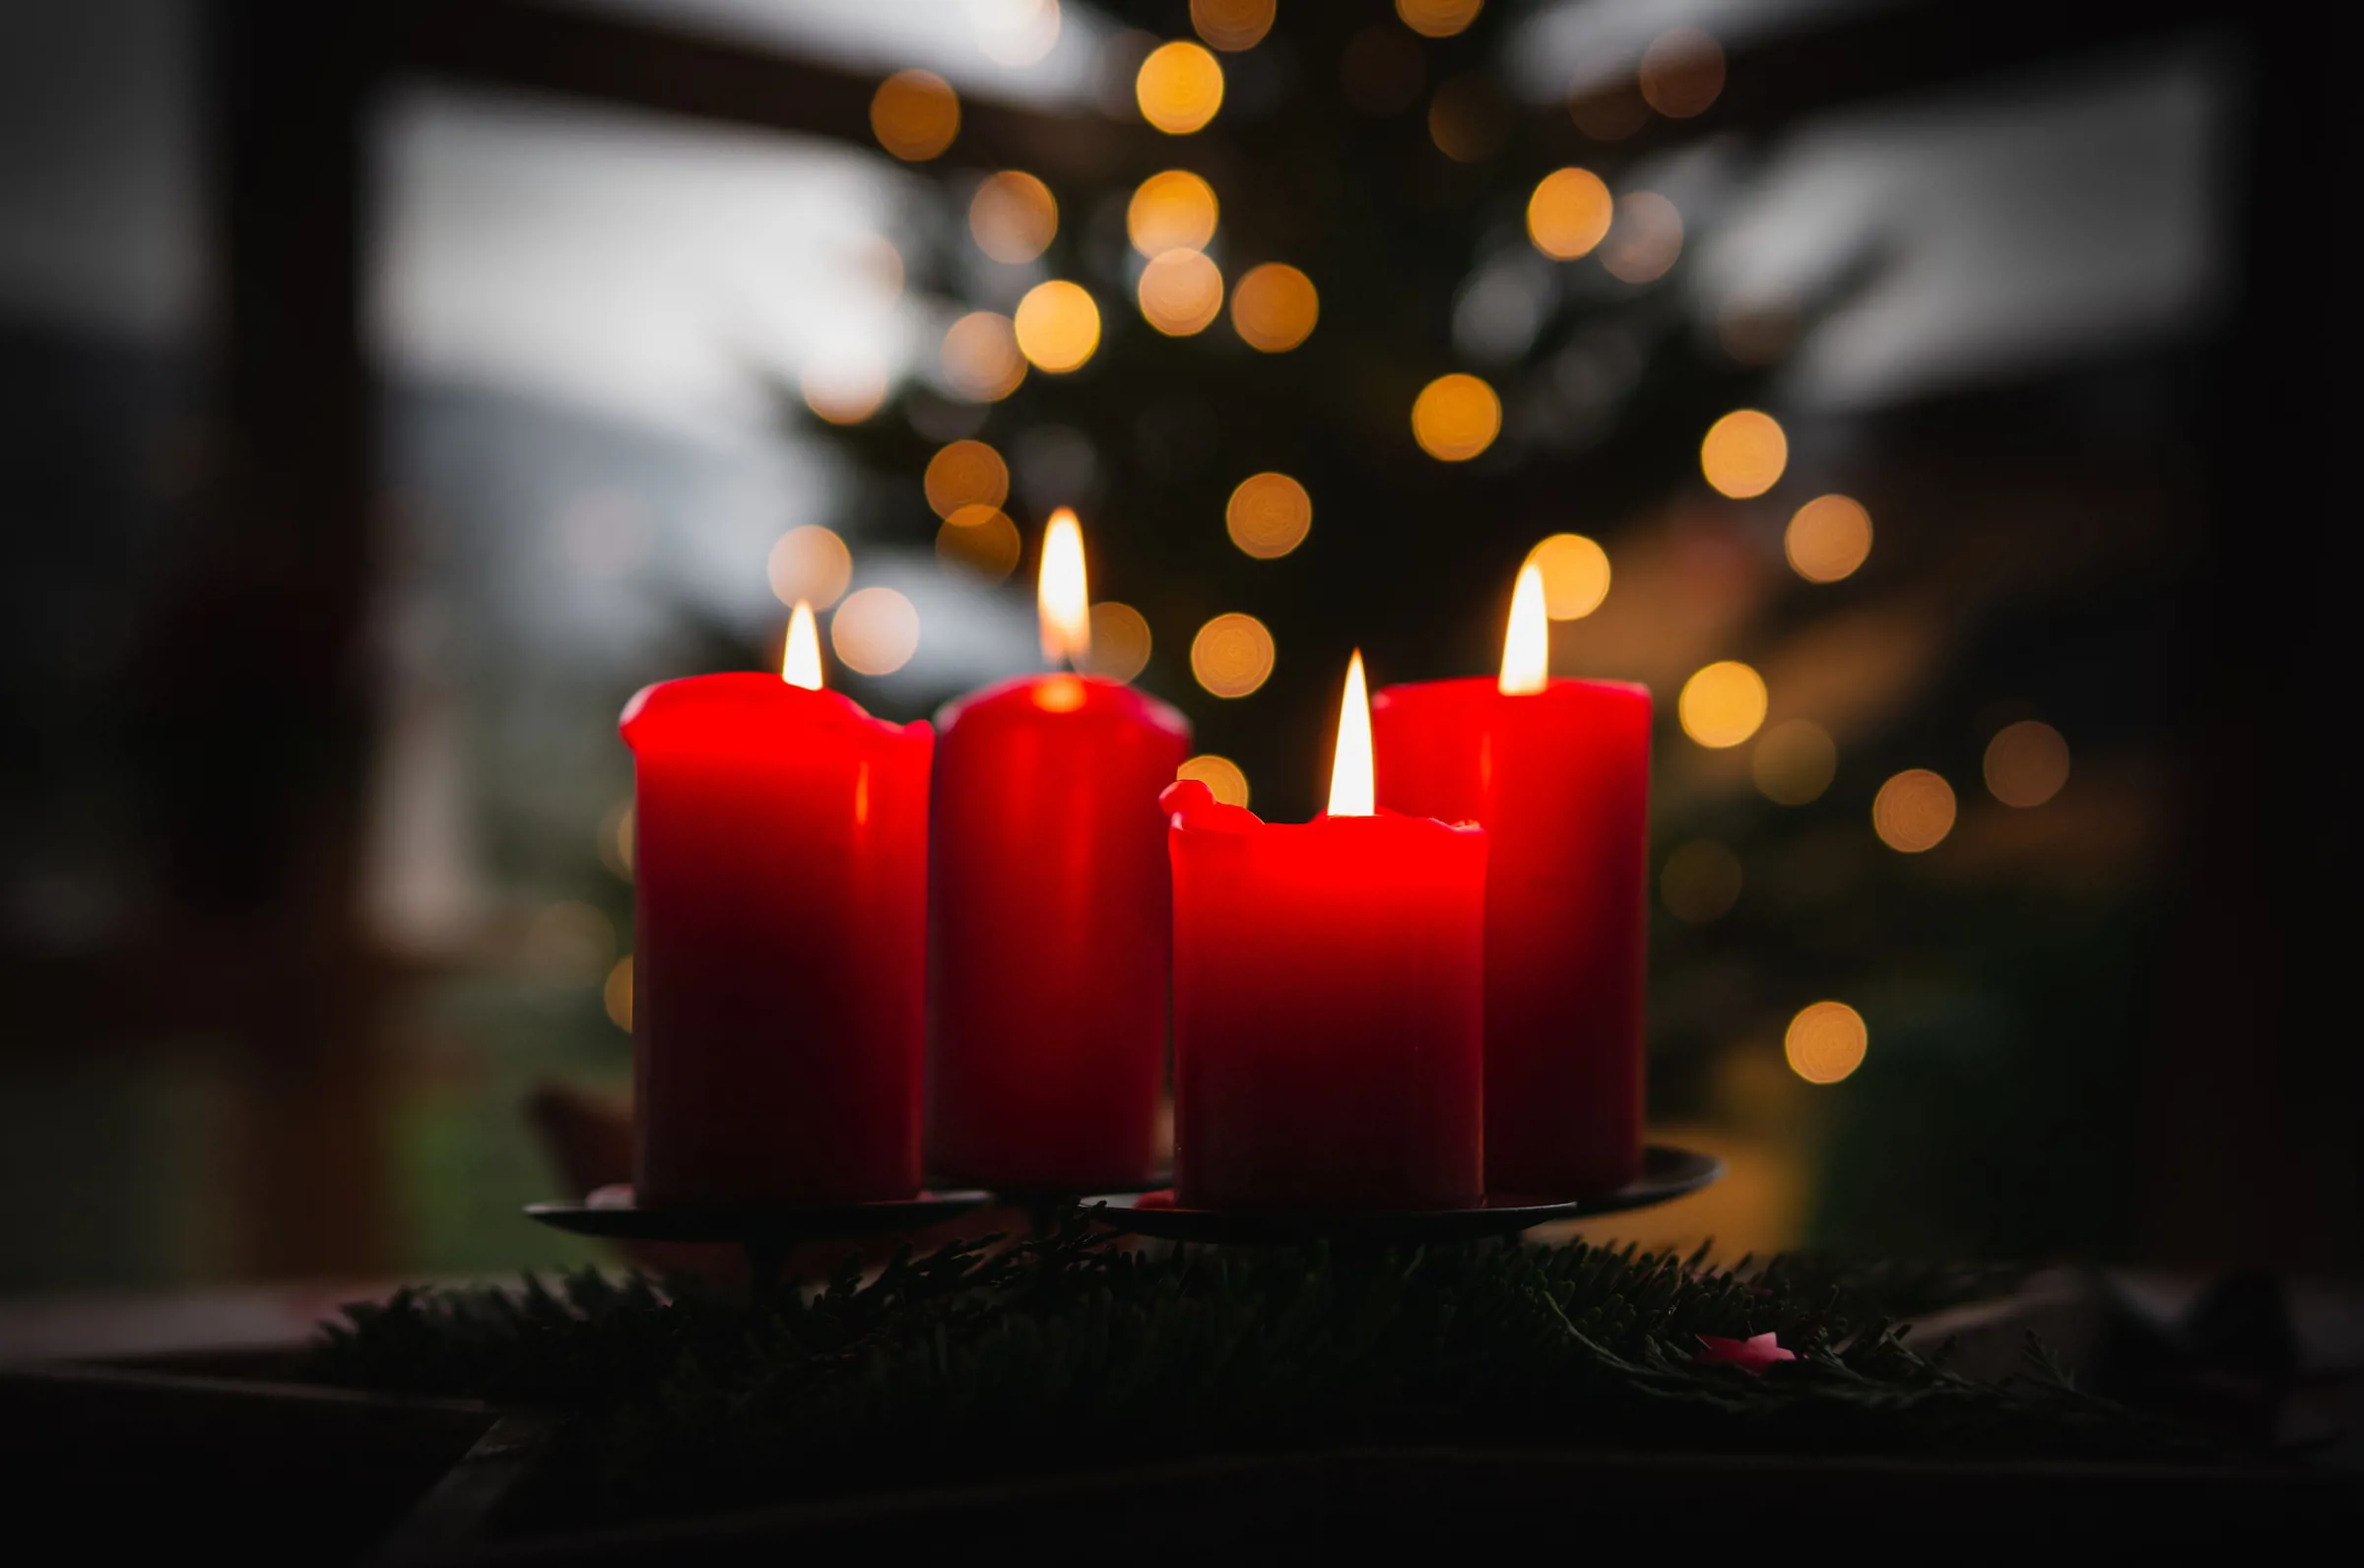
top-left (305, 1220), bottom-right (2197, 1519)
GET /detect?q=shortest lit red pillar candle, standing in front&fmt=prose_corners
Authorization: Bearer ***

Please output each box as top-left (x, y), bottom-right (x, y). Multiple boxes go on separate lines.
top-left (1165, 655), bottom-right (1487, 1209)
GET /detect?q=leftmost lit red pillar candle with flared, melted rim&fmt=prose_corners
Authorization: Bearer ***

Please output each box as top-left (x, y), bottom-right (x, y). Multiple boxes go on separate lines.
top-left (622, 606), bottom-right (934, 1204)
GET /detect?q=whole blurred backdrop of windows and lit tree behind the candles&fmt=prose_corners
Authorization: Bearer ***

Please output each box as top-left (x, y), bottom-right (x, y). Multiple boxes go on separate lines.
top-left (0, 0), bottom-right (2364, 1291)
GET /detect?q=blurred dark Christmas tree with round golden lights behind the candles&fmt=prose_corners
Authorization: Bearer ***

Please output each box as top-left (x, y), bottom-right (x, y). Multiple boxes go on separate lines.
top-left (784, 0), bottom-right (2141, 1251)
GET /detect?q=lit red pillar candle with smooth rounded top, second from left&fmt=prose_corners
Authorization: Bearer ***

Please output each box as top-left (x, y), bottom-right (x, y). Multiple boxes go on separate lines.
top-left (929, 511), bottom-right (1189, 1192)
